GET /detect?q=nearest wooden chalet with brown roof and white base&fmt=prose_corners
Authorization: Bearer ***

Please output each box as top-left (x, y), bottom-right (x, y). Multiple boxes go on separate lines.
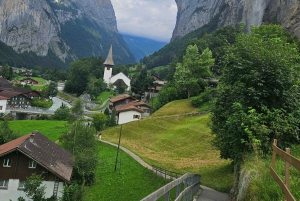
top-left (0, 131), bottom-right (73, 201)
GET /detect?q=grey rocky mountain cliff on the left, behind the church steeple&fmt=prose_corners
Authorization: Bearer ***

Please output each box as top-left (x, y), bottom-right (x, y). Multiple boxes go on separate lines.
top-left (0, 0), bottom-right (135, 68)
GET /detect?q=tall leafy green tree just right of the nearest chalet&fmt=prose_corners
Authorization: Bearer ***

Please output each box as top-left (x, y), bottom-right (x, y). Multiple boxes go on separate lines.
top-left (60, 121), bottom-right (98, 185)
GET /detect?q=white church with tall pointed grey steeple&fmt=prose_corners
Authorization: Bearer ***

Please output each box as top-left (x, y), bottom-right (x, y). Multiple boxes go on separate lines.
top-left (103, 45), bottom-right (131, 91)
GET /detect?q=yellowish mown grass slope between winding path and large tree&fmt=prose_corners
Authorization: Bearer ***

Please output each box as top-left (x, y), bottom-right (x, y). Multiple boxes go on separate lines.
top-left (102, 100), bottom-right (233, 191)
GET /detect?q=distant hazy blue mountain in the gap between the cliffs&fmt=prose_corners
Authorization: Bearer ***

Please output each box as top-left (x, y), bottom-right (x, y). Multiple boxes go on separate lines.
top-left (122, 34), bottom-right (167, 61)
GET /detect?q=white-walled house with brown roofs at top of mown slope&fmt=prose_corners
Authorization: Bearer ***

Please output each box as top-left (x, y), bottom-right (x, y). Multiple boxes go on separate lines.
top-left (116, 100), bottom-right (152, 124)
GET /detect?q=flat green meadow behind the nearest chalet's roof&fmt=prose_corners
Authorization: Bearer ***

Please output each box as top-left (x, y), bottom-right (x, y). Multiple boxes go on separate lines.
top-left (9, 120), bottom-right (70, 141)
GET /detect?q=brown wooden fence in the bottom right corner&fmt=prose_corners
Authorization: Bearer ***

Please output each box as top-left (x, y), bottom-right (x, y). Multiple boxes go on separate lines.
top-left (270, 139), bottom-right (300, 201)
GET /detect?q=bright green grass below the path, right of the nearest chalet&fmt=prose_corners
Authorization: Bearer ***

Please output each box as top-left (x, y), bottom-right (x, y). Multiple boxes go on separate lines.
top-left (83, 142), bottom-right (169, 201)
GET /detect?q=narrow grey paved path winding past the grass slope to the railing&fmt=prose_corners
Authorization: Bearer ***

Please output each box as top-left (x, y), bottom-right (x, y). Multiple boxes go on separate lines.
top-left (101, 140), bottom-right (230, 201)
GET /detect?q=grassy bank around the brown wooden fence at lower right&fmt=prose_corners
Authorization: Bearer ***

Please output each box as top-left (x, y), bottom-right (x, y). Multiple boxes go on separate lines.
top-left (240, 145), bottom-right (300, 201)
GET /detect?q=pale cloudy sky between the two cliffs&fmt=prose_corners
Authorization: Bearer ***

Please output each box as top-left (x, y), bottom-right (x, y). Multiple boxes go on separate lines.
top-left (111, 0), bottom-right (177, 42)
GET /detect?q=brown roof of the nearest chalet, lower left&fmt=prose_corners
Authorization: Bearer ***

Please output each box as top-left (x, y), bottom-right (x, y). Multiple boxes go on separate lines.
top-left (0, 131), bottom-right (73, 182)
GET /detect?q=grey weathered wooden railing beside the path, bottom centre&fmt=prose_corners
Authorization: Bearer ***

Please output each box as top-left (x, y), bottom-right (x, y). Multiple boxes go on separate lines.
top-left (141, 173), bottom-right (200, 201)
